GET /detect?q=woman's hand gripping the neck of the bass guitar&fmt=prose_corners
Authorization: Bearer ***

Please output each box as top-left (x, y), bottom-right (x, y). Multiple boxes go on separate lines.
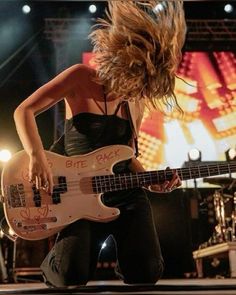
top-left (148, 167), bottom-right (182, 193)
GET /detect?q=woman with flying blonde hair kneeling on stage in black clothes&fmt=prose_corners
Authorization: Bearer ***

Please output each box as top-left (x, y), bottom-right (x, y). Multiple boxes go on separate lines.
top-left (14, 0), bottom-right (185, 287)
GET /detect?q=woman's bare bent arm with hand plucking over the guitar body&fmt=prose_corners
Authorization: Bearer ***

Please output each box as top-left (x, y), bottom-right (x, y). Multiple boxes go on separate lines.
top-left (14, 65), bottom-right (88, 192)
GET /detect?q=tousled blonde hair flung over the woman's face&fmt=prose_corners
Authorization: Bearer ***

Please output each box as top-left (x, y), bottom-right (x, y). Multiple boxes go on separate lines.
top-left (90, 0), bottom-right (186, 108)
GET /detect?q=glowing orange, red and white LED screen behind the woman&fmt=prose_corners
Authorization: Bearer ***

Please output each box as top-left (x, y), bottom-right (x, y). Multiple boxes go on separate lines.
top-left (83, 52), bottom-right (236, 185)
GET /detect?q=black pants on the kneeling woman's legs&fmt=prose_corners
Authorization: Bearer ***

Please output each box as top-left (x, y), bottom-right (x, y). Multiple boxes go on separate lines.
top-left (41, 189), bottom-right (163, 287)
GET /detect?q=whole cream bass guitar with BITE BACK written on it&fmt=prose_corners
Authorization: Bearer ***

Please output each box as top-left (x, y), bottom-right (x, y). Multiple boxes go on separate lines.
top-left (1, 145), bottom-right (236, 240)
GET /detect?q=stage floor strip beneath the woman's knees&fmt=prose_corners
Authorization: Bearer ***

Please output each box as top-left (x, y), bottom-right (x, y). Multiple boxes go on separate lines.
top-left (0, 279), bottom-right (236, 295)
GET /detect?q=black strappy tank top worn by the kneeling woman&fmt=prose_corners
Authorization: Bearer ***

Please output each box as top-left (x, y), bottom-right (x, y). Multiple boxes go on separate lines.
top-left (64, 100), bottom-right (132, 172)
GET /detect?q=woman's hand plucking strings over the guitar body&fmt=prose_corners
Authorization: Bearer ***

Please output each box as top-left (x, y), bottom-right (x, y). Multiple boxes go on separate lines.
top-left (29, 151), bottom-right (53, 194)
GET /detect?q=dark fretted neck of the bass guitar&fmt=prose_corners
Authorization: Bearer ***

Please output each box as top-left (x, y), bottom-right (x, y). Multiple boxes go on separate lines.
top-left (92, 161), bottom-right (236, 193)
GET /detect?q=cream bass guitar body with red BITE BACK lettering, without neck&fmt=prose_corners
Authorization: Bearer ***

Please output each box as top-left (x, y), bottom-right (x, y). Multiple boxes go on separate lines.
top-left (1, 145), bottom-right (133, 240)
